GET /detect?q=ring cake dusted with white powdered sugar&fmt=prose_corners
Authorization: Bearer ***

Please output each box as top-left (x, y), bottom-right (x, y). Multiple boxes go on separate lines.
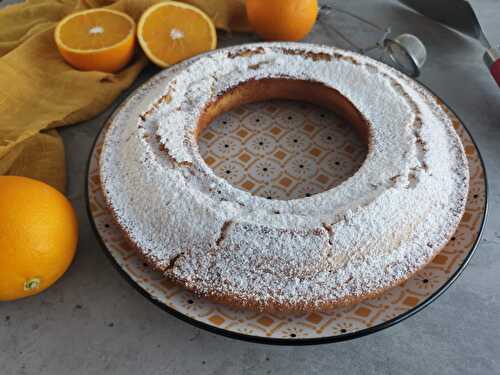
top-left (100, 43), bottom-right (469, 312)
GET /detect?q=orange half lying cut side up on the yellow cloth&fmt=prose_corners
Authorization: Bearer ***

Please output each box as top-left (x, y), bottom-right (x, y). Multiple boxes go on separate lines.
top-left (54, 8), bottom-right (135, 73)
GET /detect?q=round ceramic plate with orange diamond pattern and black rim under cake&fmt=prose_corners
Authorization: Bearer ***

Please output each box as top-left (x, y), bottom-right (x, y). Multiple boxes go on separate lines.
top-left (87, 49), bottom-right (487, 345)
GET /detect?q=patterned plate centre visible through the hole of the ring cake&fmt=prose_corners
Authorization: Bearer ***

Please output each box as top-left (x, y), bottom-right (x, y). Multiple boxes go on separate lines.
top-left (199, 100), bottom-right (367, 200)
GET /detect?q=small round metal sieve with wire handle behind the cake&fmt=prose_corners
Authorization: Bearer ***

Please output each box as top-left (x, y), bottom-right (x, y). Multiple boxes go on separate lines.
top-left (319, 4), bottom-right (427, 77)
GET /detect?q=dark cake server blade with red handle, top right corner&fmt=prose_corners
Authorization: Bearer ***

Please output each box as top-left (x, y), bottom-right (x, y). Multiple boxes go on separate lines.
top-left (399, 0), bottom-right (500, 86)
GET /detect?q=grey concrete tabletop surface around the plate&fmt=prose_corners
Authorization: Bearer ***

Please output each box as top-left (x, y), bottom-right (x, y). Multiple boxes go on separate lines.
top-left (0, 0), bottom-right (500, 375)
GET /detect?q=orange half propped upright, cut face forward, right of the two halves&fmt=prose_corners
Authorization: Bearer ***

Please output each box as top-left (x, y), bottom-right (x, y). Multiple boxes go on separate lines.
top-left (137, 1), bottom-right (217, 67)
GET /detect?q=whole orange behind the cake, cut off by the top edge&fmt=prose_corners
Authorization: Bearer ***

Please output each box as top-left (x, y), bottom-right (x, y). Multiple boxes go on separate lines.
top-left (246, 0), bottom-right (318, 41)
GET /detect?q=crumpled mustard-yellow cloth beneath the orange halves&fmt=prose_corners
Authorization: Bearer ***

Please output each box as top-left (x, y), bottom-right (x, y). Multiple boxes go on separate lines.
top-left (0, 0), bottom-right (248, 192)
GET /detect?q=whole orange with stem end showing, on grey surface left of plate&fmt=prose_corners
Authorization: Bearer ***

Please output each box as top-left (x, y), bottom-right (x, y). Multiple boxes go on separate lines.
top-left (0, 176), bottom-right (78, 301)
